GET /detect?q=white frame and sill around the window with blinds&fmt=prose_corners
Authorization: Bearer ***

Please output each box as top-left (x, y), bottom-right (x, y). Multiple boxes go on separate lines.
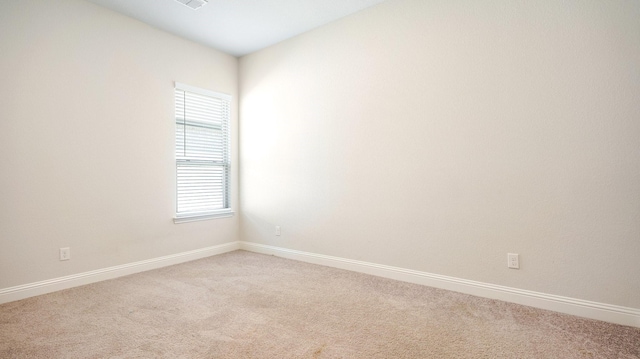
top-left (173, 82), bottom-right (234, 223)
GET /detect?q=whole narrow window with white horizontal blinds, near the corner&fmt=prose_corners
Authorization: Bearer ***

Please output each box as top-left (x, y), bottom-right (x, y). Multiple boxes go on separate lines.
top-left (174, 82), bottom-right (233, 223)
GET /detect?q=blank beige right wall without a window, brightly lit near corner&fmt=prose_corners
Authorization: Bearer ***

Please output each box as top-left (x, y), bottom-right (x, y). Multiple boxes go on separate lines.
top-left (240, 0), bottom-right (640, 308)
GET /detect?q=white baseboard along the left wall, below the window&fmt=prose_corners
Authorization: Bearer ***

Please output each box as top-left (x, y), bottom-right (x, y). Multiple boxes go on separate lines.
top-left (0, 241), bottom-right (240, 304)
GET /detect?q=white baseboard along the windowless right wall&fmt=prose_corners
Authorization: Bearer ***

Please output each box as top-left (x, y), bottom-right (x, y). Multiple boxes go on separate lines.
top-left (240, 241), bottom-right (640, 328)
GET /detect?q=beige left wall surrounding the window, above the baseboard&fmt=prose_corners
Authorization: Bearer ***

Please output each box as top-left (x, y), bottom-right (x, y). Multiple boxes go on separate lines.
top-left (0, 0), bottom-right (238, 288)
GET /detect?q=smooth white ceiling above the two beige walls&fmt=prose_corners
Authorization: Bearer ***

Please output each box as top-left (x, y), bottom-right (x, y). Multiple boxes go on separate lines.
top-left (88, 0), bottom-right (384, 56)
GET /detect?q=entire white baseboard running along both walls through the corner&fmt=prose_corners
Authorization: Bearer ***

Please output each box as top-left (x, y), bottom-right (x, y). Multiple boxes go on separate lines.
top-left (0, 241), bottom-right (640, 328)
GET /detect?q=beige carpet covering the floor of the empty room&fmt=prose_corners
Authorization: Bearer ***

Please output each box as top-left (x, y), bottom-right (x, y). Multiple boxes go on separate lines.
top-left (0, 251), bottom-right (640, 358)
